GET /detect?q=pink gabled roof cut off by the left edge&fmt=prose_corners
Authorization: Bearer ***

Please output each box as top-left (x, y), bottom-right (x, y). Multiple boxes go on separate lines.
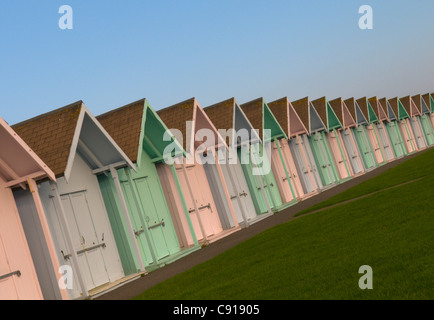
top-left (0, 117), bottom-right (56, 184)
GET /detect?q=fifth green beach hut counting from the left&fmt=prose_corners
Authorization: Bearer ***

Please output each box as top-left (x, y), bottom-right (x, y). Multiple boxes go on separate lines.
top-left (378, 98), bottom-right (407, 158)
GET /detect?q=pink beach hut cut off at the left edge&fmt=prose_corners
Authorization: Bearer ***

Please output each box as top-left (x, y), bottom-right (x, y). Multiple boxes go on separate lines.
top-left (0, 118), bottom-right (68, 300)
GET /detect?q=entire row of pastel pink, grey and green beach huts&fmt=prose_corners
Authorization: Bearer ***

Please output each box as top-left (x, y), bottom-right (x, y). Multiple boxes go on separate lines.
top-left (0, 94), bottom-right (434, 300)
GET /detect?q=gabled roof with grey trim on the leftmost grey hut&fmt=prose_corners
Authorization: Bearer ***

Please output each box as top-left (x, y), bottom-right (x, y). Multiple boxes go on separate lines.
top-left (12, 101), bottom-right (135, 180)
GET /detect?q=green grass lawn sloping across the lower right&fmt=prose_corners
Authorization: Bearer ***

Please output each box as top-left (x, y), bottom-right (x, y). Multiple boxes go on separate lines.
top-left (135, 150), bottom-right (434, 300)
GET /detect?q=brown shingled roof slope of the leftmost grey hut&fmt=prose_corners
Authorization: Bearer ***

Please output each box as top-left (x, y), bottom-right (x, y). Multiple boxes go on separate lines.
top-left (12, 101), bottom-right (83, 177)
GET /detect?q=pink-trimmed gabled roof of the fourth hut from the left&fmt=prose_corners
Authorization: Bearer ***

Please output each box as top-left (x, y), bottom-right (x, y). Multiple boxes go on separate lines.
top-left (157, 98), bottom-right (228, 154)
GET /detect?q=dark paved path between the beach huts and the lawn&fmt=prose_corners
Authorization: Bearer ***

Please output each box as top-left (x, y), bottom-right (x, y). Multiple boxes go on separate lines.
top-left (96, 151), bottom-right (424, 300)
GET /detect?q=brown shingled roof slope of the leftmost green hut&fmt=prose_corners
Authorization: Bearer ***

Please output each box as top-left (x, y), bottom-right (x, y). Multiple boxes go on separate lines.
top-left (97, 99), bottom-right (146, 162)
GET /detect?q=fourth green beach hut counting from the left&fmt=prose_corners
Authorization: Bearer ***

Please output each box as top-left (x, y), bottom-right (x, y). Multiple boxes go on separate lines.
top-left (344, 98), bottom-right (377, 171)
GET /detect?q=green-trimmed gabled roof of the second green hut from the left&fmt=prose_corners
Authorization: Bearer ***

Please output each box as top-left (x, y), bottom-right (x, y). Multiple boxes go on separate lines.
top-left (240, 98), bottom-right (287, 141)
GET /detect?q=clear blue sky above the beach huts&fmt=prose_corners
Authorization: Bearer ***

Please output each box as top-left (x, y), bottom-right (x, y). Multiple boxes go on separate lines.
top-left (0, 0), bottom-right (434, 124)
